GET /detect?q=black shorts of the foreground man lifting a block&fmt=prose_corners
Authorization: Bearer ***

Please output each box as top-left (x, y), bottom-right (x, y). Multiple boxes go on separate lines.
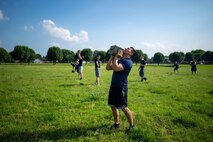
top-left (108, 86), bottom-right (128, 109)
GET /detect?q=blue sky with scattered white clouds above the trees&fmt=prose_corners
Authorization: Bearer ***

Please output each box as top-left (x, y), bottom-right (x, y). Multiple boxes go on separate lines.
top-left (0, 0), bottom-right (213, 58)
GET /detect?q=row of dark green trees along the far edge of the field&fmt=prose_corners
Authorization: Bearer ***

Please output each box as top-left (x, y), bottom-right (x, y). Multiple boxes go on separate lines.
top-left (0, 45), bottom-right (213, 64)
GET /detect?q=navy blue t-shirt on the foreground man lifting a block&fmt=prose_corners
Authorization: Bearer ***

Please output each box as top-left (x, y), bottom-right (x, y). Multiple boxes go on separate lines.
top-left (111, 58), bottom-right (132, 87)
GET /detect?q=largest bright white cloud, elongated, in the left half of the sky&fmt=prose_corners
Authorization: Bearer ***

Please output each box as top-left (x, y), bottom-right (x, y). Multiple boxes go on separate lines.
top-left (42, 20), bottom-right (88, 42)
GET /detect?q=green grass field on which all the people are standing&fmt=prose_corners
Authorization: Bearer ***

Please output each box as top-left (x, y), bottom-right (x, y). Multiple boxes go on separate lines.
top-left (0, 64), bottom-right (213, 142)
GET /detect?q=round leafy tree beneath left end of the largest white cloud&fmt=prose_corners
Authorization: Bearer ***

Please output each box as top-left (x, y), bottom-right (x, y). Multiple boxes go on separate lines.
top-left (46, 46), bottom-right (63, 64)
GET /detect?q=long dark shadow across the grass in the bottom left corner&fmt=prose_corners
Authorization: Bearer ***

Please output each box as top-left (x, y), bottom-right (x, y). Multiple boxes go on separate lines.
top-left (0, 125), bottom-right (109, 142)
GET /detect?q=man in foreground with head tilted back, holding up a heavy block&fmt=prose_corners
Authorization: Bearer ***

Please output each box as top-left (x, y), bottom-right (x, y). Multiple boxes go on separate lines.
top-left (106, 47), bottom-right (135, 132)
